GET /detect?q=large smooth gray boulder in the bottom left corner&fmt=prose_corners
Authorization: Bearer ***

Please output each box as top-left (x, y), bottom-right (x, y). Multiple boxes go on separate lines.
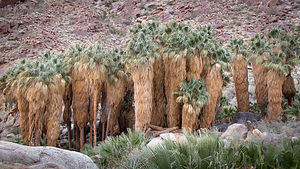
top-left (0, 141), bottom-right (98, 169)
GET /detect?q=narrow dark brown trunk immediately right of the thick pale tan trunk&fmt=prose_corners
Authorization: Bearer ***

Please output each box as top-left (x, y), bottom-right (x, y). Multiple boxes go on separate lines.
top-left (151, 58), bottom-right (166, 126)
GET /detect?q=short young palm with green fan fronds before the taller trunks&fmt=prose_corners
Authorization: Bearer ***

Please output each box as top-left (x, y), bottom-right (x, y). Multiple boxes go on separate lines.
top-left (174, 77), bottom-right (209, 131)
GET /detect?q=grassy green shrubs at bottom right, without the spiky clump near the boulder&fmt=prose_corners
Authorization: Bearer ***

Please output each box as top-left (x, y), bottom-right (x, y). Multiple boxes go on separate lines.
top-left (110, 133), bottom-right (300, 169)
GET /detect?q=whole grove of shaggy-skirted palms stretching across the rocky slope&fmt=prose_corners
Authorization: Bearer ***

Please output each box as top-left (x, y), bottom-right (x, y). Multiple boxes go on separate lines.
top-left (0, 22), bottom-right (300, 150)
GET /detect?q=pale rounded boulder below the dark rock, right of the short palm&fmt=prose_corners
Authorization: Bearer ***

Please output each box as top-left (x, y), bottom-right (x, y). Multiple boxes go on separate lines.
top-left (221, 124), bottom-right (248, 142)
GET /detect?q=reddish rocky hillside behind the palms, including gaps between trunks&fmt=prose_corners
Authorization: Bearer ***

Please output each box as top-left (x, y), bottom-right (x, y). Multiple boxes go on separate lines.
top-left (0, 0), bottom-right (300, 149)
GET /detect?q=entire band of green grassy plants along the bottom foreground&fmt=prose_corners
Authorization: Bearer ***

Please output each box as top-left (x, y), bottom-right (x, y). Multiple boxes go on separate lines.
top-left (84, 129), bottom-right (300, 169)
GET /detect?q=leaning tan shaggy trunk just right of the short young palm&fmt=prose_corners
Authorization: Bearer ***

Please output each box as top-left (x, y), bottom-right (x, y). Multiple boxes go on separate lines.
top-left (200, 64), bottom-right (223, 128)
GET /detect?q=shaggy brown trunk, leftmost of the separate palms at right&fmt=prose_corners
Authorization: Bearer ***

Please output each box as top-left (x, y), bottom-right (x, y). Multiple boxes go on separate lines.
top-left (233, 54), bottom-right (249, 112)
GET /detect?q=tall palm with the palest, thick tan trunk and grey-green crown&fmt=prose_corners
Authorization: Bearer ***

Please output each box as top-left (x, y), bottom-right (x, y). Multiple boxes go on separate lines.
top-left (127, 22), bottom-right (163, 130)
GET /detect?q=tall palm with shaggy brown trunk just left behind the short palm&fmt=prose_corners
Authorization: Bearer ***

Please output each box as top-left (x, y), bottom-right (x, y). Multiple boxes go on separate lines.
top-left (161, 22), bottom-right (193, 127)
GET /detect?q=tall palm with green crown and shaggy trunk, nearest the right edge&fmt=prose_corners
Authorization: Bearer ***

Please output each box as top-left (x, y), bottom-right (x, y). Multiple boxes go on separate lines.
top-left (263, 29), bottom-right (299, 121)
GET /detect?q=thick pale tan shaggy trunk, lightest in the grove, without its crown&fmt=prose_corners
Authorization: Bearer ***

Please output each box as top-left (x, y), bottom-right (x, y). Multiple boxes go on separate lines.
top-left (132, 65), bottom-right (154, 131)
